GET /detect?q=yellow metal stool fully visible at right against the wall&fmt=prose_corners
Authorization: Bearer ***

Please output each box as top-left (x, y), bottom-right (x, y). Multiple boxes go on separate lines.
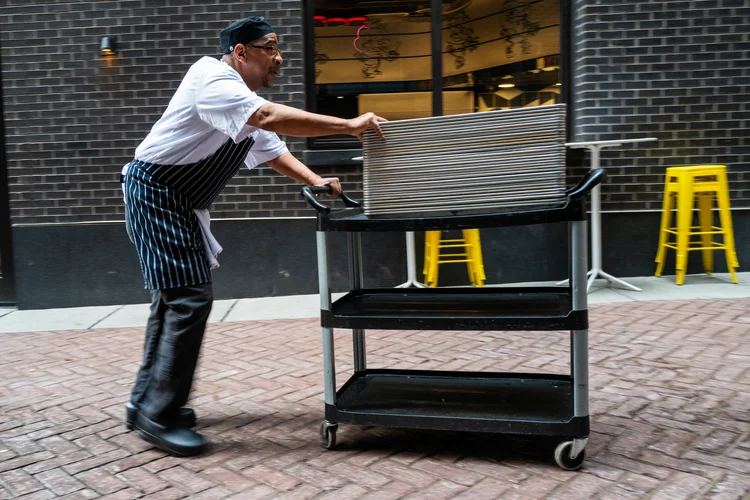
top-left (655, 165), bottom-right (740, 285)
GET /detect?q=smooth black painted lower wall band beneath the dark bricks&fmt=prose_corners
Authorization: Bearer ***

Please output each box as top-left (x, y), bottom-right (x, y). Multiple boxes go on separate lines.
top-left (13, 211), bottom-right (750, 309)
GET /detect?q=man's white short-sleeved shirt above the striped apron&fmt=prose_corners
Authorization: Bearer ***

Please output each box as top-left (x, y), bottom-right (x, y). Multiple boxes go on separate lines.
top-left (135, 57), bottom-right (289, 168)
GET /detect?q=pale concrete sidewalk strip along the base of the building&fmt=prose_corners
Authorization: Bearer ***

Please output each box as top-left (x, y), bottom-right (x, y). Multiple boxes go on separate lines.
top-left (0, 272), bottom-right (750, 333)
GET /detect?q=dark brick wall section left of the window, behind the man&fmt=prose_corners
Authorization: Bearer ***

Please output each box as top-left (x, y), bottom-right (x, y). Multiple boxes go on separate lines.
top-left (0, 0), bottom-right (360, 224)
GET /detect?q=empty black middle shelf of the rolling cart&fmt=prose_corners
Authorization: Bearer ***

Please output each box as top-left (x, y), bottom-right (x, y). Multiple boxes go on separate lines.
top-left (322, 287), bottom-right (588, 330)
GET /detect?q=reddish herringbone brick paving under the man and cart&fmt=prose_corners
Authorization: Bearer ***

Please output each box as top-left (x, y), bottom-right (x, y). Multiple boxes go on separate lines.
top-left (0, 299), bottom-right (750, 500)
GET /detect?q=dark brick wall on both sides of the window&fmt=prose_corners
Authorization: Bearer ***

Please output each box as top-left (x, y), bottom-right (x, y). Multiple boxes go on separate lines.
top-left (0, 0), bottom-right (750, 224)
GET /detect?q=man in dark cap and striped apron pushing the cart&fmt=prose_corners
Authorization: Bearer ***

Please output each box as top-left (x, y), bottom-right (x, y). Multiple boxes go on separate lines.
top-left (123, 16), bottom-right (385, 456)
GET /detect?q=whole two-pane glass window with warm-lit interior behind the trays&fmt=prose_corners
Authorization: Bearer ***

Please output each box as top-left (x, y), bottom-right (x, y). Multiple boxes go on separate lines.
top-left (309, 0), bottom-right (560, 148)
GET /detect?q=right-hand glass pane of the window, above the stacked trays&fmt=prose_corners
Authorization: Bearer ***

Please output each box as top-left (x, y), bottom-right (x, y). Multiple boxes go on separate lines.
top-left (443, 0), bottom-right (561, 114)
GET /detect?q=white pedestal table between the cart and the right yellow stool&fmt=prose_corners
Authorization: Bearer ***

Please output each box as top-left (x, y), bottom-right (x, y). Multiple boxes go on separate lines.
top-left (560, 137), bottom-right (658, 292)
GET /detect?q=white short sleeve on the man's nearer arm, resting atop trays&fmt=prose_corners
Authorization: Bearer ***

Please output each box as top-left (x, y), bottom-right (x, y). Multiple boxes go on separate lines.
top-left (195, 68), bottom-right (268, 142)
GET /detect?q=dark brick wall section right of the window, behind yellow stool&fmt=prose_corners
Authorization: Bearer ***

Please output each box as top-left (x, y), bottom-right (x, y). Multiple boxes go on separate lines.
top-left (572, 0), bottom-right (750, 210)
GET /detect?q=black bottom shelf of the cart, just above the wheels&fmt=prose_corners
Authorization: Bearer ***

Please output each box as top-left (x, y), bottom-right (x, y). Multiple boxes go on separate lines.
top-left (326, 370), bottom-right (589, 437)
